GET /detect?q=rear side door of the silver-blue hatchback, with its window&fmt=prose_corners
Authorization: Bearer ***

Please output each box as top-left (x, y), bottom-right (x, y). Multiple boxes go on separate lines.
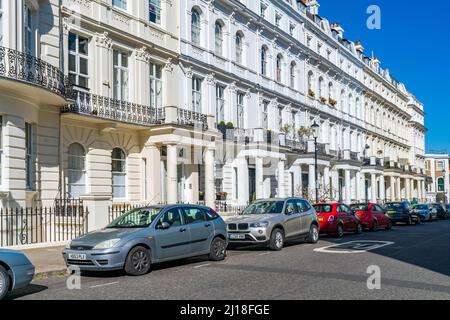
top-left (183, 207), bottom-right (214, 255)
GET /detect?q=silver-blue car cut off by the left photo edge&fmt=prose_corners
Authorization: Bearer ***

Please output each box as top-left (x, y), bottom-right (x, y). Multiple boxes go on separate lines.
top-left (0, 249), bottom-right (35, 300)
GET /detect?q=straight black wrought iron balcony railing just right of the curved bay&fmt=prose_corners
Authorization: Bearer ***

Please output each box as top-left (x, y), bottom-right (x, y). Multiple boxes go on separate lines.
top-left (61, 90), bottom-right (160, 126)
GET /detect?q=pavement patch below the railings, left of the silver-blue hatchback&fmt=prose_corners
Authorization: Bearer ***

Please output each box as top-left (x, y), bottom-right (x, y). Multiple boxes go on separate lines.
top-left (21, 247), bottom-right (67, 276)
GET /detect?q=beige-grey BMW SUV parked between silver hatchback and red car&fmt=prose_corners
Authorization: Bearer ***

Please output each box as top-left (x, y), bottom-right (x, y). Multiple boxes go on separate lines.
top-left (227, 198), bottom-right (319, 251)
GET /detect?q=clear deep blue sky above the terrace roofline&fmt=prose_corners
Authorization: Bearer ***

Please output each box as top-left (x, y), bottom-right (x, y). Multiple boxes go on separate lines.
top-left (319, 0), bottom-right (450, 153)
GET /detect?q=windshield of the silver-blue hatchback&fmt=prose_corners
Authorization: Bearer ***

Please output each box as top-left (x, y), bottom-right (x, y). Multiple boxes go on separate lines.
top-left (107, 208), bottom-right (161, 229)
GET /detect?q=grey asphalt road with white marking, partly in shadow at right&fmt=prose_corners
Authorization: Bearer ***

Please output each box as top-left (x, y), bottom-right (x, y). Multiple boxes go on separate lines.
top-left (9, 221), bottom-right (450, 300)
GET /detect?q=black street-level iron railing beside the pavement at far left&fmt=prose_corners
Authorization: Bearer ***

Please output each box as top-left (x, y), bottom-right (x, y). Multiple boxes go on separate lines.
top-left (0, 206), bottom-right (88, 247)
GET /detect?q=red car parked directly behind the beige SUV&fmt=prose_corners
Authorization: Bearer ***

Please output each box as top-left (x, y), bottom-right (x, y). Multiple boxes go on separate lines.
top-left (314, 203), bottom-right (363, 238)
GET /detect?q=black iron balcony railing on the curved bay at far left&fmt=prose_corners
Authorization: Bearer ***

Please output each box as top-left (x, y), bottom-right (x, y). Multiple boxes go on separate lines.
top-left (0, 46), bottom-right (66, 96)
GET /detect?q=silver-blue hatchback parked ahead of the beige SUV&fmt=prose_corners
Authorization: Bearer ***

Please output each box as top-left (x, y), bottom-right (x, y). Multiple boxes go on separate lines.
top-left (63, 205), bottom-right (227, 276)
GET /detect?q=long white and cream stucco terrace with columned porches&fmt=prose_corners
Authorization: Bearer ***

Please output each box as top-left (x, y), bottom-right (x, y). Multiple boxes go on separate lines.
top-left (0, 0), bottom-right (427, 229)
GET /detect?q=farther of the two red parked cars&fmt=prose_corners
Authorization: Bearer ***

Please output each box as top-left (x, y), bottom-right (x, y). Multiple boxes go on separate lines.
top-left (350, 203), bottom-right (392, 231)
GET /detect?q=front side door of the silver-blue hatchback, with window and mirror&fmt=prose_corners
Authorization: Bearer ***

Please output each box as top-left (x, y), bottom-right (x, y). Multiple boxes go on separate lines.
top-left (155, 208), bottom-right (191, 259)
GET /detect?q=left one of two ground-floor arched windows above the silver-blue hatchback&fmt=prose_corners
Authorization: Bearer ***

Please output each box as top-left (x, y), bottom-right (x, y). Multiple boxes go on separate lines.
top-left (67, 143), bottom-right (86, 198)
